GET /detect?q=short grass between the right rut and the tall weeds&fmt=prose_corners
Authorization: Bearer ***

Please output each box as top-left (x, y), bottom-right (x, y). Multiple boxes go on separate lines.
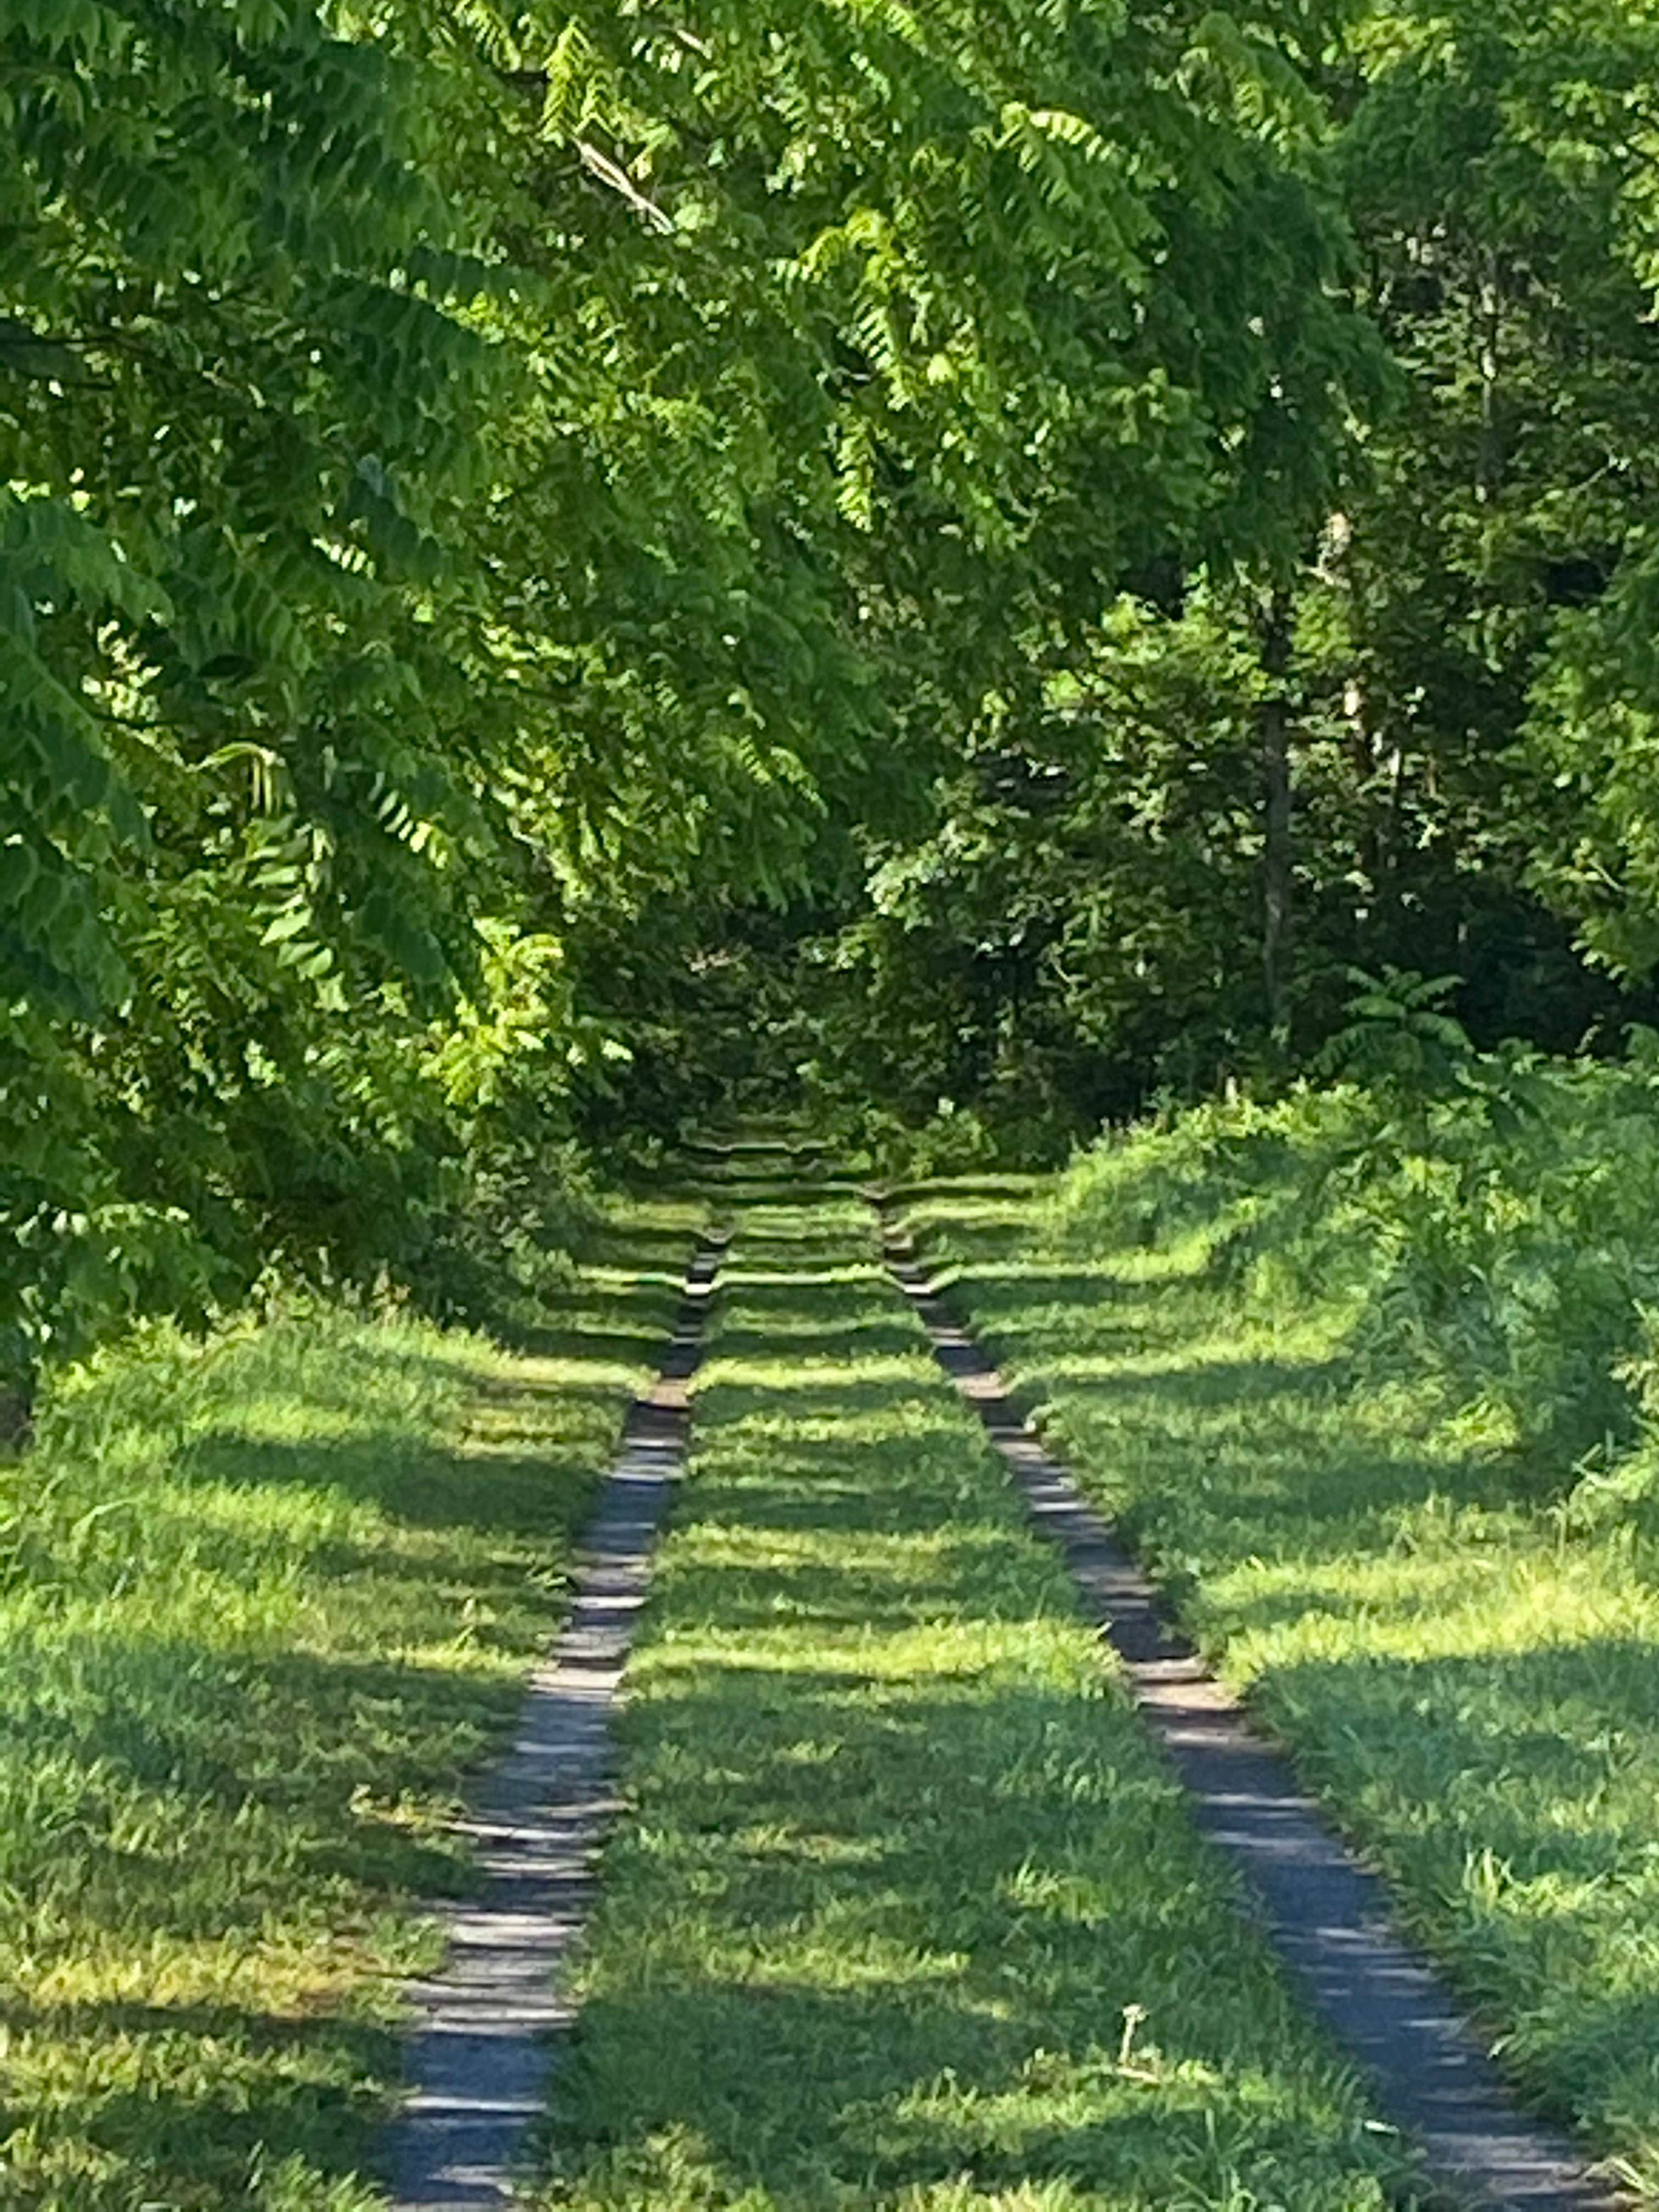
top-left (909, 1181), bottom-right (1659, 2201)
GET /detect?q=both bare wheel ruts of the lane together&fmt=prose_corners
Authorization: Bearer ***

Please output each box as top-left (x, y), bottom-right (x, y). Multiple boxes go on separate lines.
top-left (380, 1148), bottom-right (1619, 2212)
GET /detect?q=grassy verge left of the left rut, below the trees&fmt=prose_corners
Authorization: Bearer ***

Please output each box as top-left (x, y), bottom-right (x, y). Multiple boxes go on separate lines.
top-left (0, 1203), bottom-right (692, 2212)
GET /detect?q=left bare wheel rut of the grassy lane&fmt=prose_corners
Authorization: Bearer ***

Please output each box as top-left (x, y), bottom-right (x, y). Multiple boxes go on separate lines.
top-left (390, 1239), bottom-right (723, 2212)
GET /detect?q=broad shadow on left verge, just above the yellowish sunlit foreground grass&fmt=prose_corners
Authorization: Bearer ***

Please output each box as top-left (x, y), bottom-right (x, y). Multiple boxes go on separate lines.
top-left (0, 1637), bottom-right (539, 1942)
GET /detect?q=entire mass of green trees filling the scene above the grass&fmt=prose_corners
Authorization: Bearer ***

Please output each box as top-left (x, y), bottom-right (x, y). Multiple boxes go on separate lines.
top-left (0, 0), bottom-right (1659, 1420)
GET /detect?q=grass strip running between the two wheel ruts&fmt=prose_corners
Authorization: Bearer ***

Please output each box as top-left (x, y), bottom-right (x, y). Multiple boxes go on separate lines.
top-left (538, 1199), bottom-right (1398, 2212)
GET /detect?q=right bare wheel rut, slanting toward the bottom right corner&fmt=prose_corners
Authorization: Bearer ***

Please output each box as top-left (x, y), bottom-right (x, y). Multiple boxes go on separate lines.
top-left (883, 1223), bottom-right (1621, 2212)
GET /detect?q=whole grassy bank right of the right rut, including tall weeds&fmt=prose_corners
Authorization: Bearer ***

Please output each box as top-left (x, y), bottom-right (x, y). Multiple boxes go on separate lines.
top-left (909, 1070), bottom-right (1659, 2201)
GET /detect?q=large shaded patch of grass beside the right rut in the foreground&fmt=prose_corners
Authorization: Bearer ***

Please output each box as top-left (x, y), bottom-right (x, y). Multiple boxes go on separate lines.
top-left (1261, 1619), bottom-right (1659, 2141)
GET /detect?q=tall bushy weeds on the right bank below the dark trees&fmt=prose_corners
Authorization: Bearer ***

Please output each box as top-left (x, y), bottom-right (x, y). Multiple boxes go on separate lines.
top-left (1048, 975), bottom-right (1659, 1496)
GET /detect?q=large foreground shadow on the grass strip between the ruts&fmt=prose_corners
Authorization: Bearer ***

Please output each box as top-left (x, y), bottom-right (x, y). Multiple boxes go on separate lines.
top-left (555, 1645), bottom-right (1387, 2208)
